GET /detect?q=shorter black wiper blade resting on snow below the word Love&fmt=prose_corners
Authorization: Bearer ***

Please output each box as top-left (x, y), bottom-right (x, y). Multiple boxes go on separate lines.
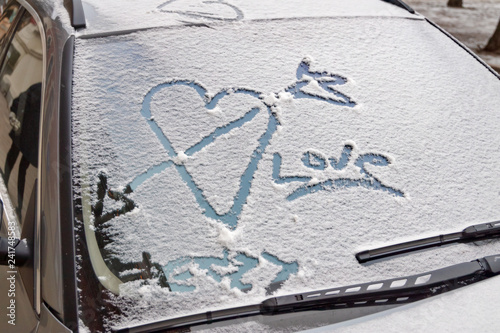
top-left (356, 221), bottom-right (500, 263)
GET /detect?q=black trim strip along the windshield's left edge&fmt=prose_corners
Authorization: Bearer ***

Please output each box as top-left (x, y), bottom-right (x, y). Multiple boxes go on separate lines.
top-left (59, 36), bottom-right (78, 332)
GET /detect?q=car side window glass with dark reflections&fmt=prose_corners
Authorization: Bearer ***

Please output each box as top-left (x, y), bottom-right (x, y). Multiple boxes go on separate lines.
top-left (0, 11), bottom-right (43, 226)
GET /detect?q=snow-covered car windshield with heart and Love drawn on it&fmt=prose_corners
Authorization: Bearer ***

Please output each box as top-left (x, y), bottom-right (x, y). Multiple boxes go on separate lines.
top-left (72, 5), bottom-right (500, 330)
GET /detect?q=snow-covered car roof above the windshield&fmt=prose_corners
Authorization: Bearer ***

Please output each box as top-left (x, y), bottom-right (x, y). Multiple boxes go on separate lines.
top-left (79, 0), bottom-right (420, 35)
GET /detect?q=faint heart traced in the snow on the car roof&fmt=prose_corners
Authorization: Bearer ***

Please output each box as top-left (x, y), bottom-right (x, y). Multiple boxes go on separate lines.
top-left (157, 0), bottom-right (243, 21)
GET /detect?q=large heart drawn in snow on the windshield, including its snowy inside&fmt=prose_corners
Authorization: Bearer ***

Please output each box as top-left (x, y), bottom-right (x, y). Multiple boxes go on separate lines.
top-left (142, 81), bottom-right (277, 227)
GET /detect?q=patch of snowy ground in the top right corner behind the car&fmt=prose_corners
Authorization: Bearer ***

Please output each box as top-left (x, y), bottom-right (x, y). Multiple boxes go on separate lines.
top-left (406, 0), bottom-right (500, 72)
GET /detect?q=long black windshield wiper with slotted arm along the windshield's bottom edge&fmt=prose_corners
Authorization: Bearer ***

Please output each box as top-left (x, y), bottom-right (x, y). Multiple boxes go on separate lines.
top-left (114, 254), bottom-right (500, 332)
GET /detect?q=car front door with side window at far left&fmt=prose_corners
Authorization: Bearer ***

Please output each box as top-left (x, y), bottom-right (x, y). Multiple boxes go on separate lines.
top-left (0, 2), bottom-right (43, 332)
